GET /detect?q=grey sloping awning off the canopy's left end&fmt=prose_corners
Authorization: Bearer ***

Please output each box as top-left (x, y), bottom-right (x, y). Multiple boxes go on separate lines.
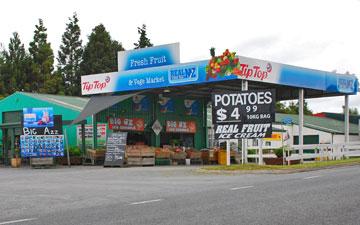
top-left (71, 92), bottom-right (141, 124)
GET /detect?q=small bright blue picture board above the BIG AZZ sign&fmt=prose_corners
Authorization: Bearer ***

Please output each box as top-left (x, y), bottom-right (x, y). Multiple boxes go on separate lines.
top-left (23, 107), bottom-right (54, 128)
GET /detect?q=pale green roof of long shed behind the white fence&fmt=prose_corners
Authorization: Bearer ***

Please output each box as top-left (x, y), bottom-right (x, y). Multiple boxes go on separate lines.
top-left (275, 113), bottom-right (359, 135)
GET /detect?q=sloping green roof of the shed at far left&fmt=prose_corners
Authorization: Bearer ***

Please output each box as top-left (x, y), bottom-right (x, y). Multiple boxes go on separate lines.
top-left (18, 92), bottom-right (89, 112)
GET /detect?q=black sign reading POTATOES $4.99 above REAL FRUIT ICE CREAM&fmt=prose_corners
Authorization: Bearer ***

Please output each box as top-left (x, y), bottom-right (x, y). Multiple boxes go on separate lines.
top-left (212, 90), bottom-right (275, 139)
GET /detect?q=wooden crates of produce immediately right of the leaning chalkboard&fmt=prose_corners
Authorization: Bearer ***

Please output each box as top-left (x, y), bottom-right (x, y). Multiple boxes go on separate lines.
top-left (125, 145), bottom-right (155, 166)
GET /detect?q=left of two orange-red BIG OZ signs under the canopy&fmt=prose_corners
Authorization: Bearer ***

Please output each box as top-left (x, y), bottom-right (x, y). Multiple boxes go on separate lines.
top-left (109, 117), bottom-right (145, 131)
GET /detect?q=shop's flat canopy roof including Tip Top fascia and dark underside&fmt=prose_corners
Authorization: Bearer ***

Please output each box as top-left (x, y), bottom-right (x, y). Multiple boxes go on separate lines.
top-left (81, 56), bottom-right (358, 98)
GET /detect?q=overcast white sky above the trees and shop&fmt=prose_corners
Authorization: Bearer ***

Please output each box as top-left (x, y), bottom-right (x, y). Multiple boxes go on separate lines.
top-left (0, 0), bottom-right (360, 112)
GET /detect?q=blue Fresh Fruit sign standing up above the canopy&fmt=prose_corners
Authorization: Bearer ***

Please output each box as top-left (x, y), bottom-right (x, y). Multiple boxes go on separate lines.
top-left (118, 43), bottom-right (180, 71)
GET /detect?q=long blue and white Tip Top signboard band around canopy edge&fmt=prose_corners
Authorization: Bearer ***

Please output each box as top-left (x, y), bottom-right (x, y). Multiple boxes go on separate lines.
top-left (81, 50), bottom-right (358, 95)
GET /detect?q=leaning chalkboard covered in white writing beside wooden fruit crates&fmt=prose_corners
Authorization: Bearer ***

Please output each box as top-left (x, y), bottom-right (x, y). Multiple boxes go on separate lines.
top-left (104, 132), bottom-right (127, 167)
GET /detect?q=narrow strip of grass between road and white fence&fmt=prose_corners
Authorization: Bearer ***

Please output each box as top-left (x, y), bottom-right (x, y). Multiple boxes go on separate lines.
top-left (202, 158), bottom-right (360, 171)
